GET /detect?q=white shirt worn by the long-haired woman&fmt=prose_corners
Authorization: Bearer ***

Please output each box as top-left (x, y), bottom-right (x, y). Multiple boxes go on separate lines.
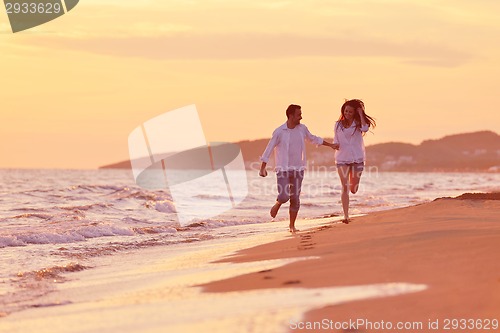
top-left (333, 121), bottom-right (369, 164)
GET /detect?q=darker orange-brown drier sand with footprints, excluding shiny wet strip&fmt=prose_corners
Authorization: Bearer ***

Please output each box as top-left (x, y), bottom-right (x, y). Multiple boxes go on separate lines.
top-left (204, 193), bottom-right (500, 332)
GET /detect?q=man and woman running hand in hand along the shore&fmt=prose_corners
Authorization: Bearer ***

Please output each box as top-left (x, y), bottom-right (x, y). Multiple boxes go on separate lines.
top-left (259, 99), bottom-right (376, 233)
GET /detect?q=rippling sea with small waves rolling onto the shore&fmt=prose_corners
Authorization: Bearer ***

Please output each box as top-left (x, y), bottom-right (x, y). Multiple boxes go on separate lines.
top-left (0, 168), bottom-right (500, 317)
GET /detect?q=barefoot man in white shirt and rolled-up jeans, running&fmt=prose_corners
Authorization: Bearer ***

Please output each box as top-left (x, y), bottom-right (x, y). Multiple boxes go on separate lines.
top-left (259, 104), bottom-right (338, 233)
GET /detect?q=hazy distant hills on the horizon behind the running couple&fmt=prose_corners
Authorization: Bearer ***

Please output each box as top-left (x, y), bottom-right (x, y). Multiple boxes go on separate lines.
top-left (100, 131), bottom-right (500, 172)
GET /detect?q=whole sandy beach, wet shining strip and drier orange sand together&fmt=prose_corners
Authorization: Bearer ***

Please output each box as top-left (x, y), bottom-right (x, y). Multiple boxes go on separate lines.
top-left (0, 194), bottom-right (500, 332)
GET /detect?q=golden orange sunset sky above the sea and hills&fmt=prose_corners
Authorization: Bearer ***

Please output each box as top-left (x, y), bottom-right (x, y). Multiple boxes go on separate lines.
top-left (0, 0), bottom-right (500, 168)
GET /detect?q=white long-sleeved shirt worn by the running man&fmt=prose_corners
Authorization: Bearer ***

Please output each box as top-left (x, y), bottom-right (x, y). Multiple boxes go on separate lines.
top-left (260, 123), bottom-right (323, 172)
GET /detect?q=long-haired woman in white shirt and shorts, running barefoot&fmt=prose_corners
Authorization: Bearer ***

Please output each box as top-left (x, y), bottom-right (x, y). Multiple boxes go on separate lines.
top-left (333, 99), bottom-right (376, 224)
